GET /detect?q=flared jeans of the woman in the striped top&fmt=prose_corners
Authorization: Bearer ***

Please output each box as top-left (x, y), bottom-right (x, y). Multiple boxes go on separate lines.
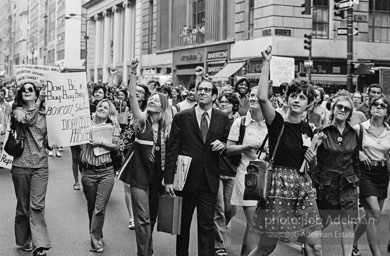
top-left (81, 167), bottom-right (115, 249)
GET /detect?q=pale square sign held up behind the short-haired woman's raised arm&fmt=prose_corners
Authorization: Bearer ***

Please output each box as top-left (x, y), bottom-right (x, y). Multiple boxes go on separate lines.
top-left (270, 56), bottom-right (295, 87)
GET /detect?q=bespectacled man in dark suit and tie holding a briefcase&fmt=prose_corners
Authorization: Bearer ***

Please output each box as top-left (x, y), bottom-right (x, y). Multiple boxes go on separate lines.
top-left (165, 80), bottom-right (229, 256)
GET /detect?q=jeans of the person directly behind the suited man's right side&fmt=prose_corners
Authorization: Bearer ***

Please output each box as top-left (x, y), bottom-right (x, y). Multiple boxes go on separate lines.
top-left (214, 175), bottom-right (236, 249)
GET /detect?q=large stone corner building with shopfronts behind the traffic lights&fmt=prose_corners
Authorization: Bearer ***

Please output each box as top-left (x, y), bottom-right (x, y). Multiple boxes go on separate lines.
top-left (141, 0), bottom-right (390, 92)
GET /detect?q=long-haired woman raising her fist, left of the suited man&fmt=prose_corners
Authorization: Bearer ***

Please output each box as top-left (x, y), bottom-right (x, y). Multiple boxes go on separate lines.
top-left (126, 60), bottom-right (172, 256)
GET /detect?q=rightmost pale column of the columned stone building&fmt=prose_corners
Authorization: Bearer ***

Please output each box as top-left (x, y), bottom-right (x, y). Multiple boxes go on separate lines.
top-left (123, 0), bottom-right (134, 85)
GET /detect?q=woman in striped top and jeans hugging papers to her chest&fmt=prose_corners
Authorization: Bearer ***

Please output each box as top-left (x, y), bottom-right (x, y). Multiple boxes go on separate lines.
top-left (80, 99), bottom-right (123, 253)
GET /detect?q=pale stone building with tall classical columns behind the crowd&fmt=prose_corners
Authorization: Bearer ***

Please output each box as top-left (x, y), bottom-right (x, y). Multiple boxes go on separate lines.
top-left (83, 0), bottom-right (142, 83)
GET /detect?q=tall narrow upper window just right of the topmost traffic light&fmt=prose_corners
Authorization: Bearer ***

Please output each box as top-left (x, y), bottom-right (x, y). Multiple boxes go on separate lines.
top-left (313, 0), bottom-right (329, 38)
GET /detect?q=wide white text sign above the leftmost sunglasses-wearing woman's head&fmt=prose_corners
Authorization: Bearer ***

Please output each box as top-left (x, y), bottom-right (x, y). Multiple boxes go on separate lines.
top-left (14, 65), bottom-right (60, 85)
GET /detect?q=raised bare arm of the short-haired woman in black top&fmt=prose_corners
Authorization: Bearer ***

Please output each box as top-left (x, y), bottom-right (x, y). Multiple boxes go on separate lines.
top-left (257, 46), bottom-right (275, 125)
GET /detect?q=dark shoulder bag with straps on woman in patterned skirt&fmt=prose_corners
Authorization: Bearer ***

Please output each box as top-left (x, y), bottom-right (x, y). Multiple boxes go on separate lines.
top-left (244, 124), bottom-right (284, 201)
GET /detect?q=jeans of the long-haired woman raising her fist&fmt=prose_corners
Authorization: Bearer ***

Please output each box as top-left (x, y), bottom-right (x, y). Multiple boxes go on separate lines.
top-left (131, 184), bottom-right (160, 256)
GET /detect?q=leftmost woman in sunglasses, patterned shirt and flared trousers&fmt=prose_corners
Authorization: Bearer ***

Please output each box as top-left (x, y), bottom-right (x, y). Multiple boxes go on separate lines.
top-left (11, 82), bottom-right (51, 256)
